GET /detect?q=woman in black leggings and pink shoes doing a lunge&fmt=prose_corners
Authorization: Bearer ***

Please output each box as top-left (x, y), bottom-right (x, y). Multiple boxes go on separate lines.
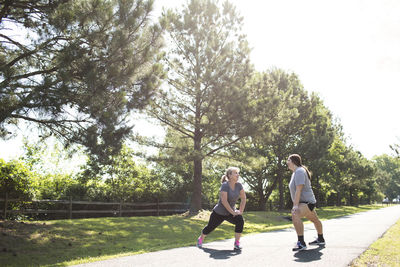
top-left (197, 167), bottom-right (246, 250)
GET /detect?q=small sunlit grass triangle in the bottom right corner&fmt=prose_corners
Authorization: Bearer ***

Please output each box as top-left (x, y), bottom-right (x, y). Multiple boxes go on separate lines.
top-left (351, 220), bottom-right (400, 267)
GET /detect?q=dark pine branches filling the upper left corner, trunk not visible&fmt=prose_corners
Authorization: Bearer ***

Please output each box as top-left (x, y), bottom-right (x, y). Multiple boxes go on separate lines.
top-left (0, 0), bottom-right (163, 164)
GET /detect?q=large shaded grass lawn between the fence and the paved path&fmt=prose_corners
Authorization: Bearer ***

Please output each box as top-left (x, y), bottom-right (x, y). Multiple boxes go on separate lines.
top-left (0, 205), bottom-right (383, 266)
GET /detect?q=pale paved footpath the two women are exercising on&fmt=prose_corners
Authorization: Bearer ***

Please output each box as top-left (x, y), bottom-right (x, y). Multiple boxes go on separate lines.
top-left (76, 205), bottom-right (400, 267)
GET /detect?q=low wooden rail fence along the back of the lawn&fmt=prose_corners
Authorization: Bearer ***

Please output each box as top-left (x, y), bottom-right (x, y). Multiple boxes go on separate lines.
top-left (0, 194), bottom-right (189, 219)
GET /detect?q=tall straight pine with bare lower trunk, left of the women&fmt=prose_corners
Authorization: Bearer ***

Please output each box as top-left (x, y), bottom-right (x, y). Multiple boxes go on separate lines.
top-left (150, 0), bottom-right (252, 214)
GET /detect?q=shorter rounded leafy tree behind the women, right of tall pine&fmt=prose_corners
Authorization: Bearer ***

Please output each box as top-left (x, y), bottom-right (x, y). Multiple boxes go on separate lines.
top-left (230, 69), bottom-right (334, 210)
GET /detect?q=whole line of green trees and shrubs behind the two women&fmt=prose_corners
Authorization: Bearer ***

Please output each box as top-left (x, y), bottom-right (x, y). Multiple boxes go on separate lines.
top-left (0, 0), bottom-right (400, 214)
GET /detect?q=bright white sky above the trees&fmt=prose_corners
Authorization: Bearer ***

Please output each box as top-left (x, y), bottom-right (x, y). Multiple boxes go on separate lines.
top-left (0, 0), bottom-right (400, 159)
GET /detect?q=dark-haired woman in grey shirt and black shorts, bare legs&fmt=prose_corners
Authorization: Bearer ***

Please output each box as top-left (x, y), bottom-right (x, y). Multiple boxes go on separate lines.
top-left (287, 154), bottom-right (325, 251)
